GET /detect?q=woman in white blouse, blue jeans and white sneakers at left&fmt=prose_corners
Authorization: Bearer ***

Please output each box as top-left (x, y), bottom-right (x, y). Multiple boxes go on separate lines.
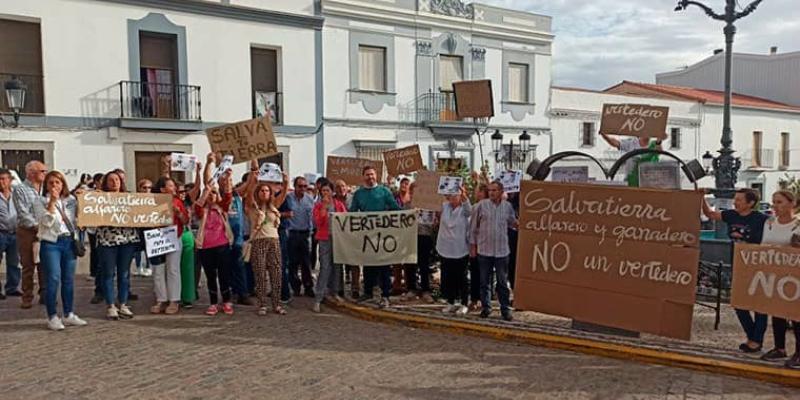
top-left (35, 171), bottom-right (86, 331)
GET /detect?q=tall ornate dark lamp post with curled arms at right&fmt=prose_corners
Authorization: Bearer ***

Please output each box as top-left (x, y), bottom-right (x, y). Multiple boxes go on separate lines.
top-left (675, 0), bottom-right (763, 209)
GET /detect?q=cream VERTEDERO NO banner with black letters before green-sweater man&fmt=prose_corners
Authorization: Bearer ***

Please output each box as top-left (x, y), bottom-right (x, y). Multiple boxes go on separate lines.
top-left (331, 210), bottom-right (417, 266)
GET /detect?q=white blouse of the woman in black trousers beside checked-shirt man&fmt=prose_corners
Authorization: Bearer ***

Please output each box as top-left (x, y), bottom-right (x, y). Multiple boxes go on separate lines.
top-left (436, 201), bottom-right (472, 258)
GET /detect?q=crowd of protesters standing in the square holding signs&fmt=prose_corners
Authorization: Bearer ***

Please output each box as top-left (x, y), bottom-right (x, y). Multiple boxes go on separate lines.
top-left (0, 139), bottom-right (800, 368)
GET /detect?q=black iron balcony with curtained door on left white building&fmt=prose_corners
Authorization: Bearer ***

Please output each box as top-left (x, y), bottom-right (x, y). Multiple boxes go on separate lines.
top-left (119, 81), bottom-right (202, 130)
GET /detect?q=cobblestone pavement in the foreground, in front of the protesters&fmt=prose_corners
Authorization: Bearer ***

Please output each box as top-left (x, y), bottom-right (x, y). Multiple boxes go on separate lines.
top-left (0, 276), bottom-right (800, 400)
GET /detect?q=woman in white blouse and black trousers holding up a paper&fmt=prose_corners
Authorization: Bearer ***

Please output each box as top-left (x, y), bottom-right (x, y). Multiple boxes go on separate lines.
top-left (436, 186), bottom-right (472, 315)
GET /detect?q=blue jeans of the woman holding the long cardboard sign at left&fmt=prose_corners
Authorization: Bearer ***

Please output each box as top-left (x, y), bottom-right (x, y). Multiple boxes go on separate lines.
top-left (97, 244), bottom-right (136, 305)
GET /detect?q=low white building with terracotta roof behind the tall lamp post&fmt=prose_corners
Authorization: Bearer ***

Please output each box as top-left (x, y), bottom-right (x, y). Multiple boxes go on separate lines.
top-left (549, 81), bottom-right (800, 195)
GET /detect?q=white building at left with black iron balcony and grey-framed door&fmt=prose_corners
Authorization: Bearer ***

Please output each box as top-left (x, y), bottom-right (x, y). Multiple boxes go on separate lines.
top-left (0, 0), bottom-right (324, 187)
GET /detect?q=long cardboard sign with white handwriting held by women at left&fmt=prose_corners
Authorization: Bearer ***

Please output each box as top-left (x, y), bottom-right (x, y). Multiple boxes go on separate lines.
top-left (78, 192), bottom-right (172, 228)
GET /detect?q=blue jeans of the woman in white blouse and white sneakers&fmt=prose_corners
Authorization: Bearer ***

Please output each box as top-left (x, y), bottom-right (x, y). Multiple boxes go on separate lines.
top-left (39, 237), bottom-right (77, 318)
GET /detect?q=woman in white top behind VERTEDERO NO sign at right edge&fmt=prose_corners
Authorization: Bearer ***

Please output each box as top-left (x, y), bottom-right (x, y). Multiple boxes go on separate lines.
top-left (761, 190), bottom-right (800, 369)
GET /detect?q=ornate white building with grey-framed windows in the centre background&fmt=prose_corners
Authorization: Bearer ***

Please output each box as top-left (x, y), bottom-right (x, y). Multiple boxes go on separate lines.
top-left (319, 0), bottom-right (554, 172)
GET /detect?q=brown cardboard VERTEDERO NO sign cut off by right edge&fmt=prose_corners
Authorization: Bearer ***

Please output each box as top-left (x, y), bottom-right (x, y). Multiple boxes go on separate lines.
top-left (731, 243), bottom-right (800, 321)
